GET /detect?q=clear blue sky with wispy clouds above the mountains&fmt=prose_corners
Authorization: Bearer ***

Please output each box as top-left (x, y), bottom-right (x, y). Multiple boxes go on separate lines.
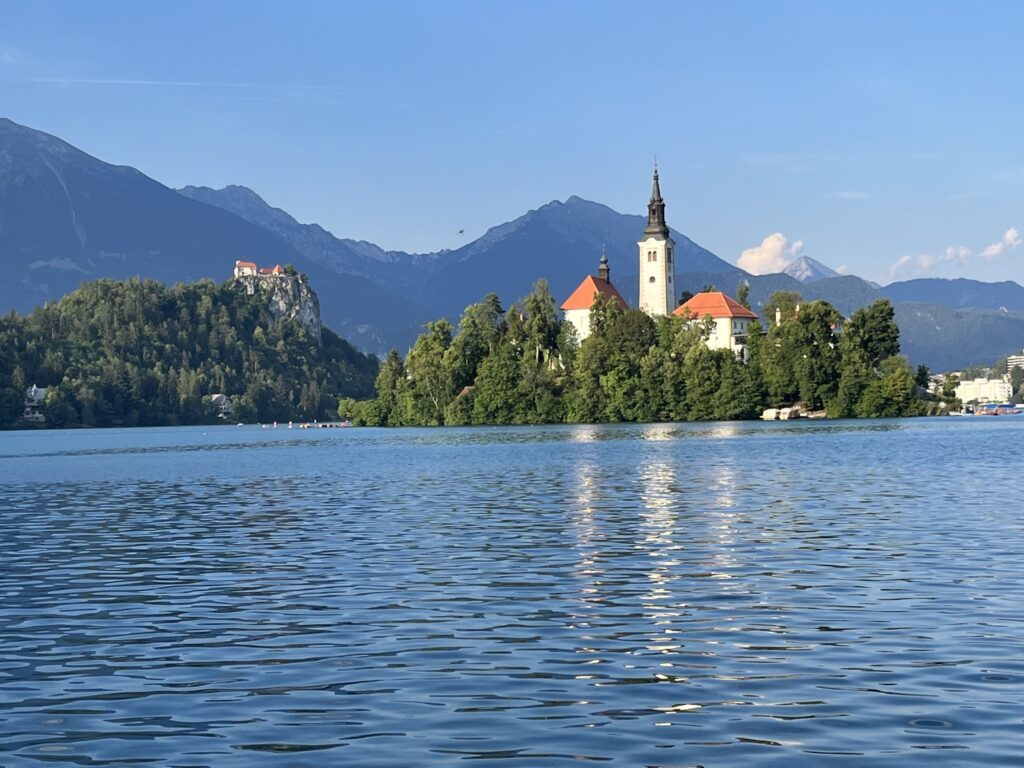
top-left (0, 0), bottom-right (1024, 283)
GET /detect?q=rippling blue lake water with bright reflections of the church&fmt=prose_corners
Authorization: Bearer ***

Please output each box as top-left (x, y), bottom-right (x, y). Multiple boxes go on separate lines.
top-left (0, 418), bottom-right (1024, 768)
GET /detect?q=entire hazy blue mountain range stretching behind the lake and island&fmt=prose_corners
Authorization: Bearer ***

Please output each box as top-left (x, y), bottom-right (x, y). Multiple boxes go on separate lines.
top-left (0, 119), bottom-right (1024, 370)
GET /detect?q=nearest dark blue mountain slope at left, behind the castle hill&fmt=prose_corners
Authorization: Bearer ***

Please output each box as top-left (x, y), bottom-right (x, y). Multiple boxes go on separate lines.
top-left (0, 119), bottom-right (422, 351)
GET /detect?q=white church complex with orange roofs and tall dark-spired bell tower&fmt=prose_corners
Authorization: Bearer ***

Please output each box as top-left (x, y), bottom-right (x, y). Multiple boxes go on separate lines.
top-left (561, 166), bottom-right (758, 357)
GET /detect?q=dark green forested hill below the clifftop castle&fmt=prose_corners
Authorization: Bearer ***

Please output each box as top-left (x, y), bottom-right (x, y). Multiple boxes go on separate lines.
top-left (0, 280), bottom-right (377, 426)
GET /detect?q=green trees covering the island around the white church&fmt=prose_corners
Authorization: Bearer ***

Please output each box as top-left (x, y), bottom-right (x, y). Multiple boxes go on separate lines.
top-left (338, 281), bottom-right (937, 426)
